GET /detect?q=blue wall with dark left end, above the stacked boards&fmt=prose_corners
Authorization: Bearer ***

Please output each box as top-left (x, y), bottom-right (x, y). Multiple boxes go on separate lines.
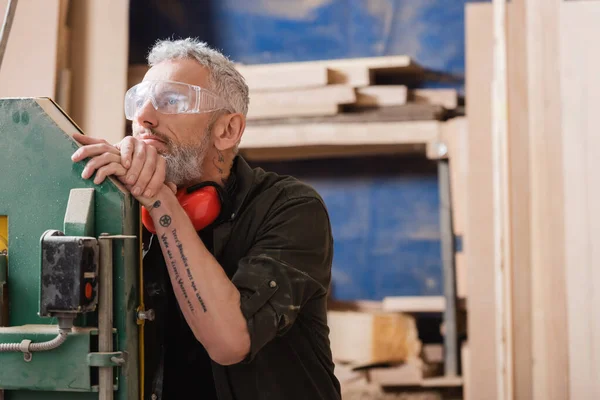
top-left (131, 0), bottom-right (468, 88)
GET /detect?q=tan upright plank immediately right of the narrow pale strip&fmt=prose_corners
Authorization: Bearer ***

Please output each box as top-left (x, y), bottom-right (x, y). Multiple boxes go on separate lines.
top-left (507, 1), bottom-right (533, 400)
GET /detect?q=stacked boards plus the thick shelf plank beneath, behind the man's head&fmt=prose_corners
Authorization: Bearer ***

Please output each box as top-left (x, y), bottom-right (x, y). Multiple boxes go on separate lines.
top-left (238, 56), bottom-right (459, 160)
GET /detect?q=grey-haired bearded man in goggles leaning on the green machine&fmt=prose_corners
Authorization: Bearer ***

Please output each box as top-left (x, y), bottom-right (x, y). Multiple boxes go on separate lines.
top-left (72, 39), bottom-right (340, 400)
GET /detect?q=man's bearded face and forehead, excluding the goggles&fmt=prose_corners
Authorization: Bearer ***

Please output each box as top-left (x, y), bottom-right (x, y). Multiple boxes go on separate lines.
top-left (132, 59), bottom-right (215, 186)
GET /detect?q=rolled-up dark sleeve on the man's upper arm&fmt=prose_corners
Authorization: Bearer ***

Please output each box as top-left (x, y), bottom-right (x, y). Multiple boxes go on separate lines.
top-left (232, 198), bottom-right (333, 363)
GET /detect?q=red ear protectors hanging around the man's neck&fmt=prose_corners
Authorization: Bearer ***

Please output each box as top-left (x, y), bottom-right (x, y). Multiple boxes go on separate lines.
top-left (142, 182), bottom-right (225, 233)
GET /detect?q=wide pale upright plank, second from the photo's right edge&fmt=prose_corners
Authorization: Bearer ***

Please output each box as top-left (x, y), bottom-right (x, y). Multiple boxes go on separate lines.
top-left (524, 0), bottom-right (568, 400)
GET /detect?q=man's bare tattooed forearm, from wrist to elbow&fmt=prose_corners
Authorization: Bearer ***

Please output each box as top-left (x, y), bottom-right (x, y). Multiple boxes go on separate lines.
top-left (150, 191), bottom-right (250, 364)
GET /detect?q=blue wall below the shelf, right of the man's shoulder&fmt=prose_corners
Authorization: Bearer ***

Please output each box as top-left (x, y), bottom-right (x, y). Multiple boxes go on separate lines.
top-left (251, 157), bottom-right (443, 300)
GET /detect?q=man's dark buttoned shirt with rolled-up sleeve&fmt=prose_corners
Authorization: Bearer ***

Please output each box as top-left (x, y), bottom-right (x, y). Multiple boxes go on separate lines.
top-left (144, 156), bottom-right (341, 400)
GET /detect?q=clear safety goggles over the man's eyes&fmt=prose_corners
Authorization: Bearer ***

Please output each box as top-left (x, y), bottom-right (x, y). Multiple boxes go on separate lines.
top-left (125, 81), bottom-right (228, 120)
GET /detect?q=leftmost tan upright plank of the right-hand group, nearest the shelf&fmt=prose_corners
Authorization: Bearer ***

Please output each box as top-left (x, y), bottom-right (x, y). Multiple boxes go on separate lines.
top-left (464, 3), bottom-right (496, 400)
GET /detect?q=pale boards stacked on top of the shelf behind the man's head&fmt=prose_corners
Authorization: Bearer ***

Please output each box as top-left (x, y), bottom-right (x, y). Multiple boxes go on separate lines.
top-left (238, 56), bottom-right (458, 121)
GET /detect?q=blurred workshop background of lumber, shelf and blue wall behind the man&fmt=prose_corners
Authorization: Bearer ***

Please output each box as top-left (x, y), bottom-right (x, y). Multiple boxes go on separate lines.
top-left (0, 0), bottom-right (600, 400)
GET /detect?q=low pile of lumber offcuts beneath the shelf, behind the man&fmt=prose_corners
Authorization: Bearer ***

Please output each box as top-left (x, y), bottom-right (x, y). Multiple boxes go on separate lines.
top-left (327, 297), bottom-right (462, 394)
